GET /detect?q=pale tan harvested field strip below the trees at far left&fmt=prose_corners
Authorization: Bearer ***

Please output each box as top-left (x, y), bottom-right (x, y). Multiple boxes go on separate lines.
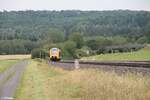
top-left (0, 55), bottom-right (31, 60)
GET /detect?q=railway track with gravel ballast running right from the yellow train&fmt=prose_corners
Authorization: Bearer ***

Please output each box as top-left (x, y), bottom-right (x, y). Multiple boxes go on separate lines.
top-left (51, 60), bottom-right (150, 75)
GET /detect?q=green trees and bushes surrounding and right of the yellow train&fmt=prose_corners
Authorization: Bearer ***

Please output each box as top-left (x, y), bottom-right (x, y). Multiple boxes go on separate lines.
top-left (32, 29), bottom-right (146, 59)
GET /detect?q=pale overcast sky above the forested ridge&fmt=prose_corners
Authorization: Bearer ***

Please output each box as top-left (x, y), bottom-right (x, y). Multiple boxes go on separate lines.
top-left (0, 0), bottom-right (150, 11)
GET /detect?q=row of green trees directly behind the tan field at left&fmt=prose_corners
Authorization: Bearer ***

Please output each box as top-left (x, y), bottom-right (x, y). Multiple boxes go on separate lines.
top-left (0, 39), bottom-right (37, 54)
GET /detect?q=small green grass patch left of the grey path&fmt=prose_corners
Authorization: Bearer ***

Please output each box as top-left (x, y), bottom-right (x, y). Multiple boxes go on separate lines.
top-left (0, 60), bottom-right (18, 73)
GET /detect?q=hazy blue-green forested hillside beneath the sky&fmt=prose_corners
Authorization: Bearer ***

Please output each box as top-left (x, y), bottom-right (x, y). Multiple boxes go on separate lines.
top-left (0, 10), bottom-right (150, 40)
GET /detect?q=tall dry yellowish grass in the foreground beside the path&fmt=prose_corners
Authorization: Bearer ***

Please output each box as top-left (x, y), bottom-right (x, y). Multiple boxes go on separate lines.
top-left (15, 61), bottom-right (150, 100)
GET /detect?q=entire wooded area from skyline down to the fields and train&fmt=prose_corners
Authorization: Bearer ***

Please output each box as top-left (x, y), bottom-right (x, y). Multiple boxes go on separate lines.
top-left (0, 10), bottom-right (150, 58)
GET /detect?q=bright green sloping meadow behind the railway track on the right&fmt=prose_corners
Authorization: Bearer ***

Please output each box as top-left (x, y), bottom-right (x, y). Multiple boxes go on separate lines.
top-left (81, 47), bottom-right (150, 61)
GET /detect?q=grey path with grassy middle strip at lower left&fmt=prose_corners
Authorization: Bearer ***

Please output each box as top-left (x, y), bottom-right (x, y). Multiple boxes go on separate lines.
top-left (0, 61), bottom-right (28, 100)
